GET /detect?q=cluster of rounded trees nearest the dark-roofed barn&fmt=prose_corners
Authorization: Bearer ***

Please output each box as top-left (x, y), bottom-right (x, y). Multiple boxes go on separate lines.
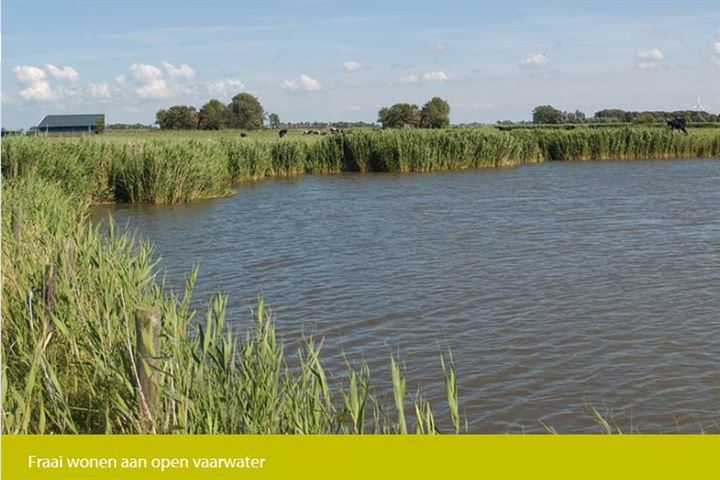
top-left (155, 93), bottom-right (280, 130)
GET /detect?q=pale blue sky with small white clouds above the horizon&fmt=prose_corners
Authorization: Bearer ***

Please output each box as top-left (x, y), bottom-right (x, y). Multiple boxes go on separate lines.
top-left (0, 0), bottom-right (720, 129)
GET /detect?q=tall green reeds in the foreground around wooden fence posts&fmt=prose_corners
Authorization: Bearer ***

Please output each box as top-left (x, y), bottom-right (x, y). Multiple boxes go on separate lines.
top-left (2, 178), bottom-right (460, 433)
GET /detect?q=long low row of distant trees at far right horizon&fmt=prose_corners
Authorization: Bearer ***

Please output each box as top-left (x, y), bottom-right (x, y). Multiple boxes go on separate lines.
top-left (533, 105), bottom-right (720, 124)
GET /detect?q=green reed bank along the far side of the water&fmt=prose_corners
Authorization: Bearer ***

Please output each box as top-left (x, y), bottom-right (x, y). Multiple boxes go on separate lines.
top-left (2, 127), bottom-right (720, 203)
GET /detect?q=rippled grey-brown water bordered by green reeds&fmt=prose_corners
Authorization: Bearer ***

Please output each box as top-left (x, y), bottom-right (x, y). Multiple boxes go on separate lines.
top-left (91, 160), bottom-right (720, 433)
